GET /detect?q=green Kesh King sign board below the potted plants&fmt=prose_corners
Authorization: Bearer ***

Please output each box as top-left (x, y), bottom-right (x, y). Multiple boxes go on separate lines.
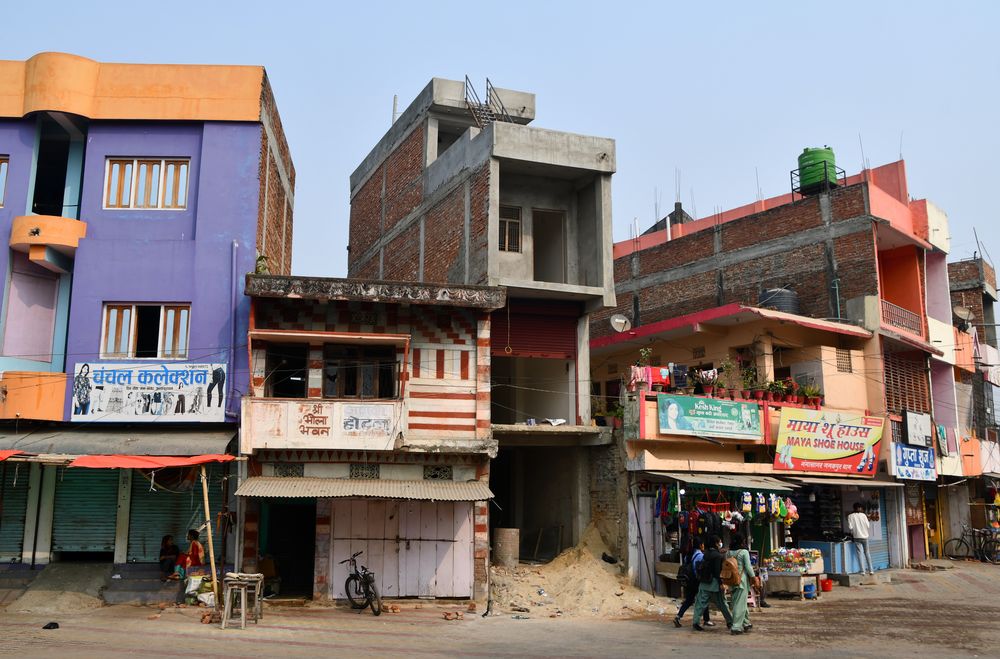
top-left (656, 394), bottom-right (763, 439)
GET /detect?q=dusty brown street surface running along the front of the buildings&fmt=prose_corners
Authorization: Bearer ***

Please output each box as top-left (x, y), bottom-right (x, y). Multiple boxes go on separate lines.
top-left (0, 563), bottom-right (1000, 659)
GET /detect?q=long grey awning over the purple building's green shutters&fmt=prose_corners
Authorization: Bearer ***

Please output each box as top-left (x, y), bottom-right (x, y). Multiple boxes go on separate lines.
top-left (0, 425), bottom-right (236, 460)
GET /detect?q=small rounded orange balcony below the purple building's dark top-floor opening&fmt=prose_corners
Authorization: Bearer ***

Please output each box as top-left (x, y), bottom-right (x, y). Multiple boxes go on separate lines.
top-left (10, 215), bottom-right (87, 274)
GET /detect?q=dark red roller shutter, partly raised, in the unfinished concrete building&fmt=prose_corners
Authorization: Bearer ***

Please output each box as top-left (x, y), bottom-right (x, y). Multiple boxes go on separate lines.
top-left (490, 304), bottom-right (580, 359)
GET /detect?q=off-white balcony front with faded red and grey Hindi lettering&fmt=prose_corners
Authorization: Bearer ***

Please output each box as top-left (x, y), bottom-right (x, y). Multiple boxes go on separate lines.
top-left (240, 396), bottom-right (406, 454)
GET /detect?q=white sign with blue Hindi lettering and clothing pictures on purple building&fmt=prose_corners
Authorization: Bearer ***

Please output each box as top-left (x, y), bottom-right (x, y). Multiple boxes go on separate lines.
top-left (70, 362), bottom-right (228, 423)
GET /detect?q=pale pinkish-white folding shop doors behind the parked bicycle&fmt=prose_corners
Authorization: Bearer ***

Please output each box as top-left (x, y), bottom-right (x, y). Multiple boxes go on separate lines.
top-left (330, 499), bottom-right (474, 599)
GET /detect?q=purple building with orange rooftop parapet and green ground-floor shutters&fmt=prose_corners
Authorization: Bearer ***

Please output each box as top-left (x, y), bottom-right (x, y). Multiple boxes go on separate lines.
top-left (0, 53), bottom-right (295, 592)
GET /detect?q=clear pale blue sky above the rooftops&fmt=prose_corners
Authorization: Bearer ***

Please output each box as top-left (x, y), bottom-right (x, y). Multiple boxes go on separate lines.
top-left (0, 0), bottom-right (1000, 276)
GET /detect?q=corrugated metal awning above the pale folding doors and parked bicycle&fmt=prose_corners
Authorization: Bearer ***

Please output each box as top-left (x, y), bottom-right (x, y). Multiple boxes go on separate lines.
top-left (236, 476), bottom-right (493, 501)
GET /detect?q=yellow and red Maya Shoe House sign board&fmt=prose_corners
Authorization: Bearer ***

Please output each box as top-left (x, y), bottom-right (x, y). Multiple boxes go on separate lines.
top-left (774, 407), bottom-right (885, 477)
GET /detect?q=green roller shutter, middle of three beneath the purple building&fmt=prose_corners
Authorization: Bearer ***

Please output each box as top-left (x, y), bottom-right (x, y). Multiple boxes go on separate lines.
top-left (52, 468), bottom-right (118, 552)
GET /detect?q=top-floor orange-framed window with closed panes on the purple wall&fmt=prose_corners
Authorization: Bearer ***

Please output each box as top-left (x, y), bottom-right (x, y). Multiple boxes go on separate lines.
top-left (104, 158), bottom-right (191, 210)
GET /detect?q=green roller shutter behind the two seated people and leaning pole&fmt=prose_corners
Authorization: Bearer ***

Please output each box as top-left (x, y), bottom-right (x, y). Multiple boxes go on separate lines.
top-left (128, 465), bottom-right (226, 563)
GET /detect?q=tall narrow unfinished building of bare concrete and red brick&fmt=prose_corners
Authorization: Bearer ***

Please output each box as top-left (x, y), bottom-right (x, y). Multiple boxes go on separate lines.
top-left (348, 78), bottom-right (615, 557)
